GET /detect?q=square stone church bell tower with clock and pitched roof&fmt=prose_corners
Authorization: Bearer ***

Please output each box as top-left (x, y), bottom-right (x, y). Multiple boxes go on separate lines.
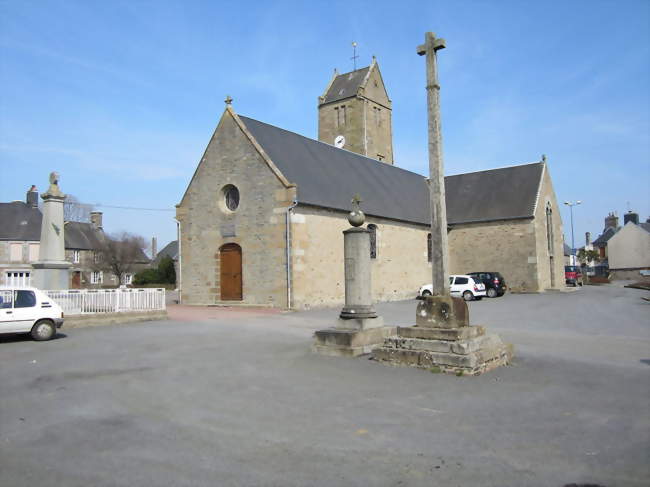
top-left (318, 56), bottom-right (393, 164)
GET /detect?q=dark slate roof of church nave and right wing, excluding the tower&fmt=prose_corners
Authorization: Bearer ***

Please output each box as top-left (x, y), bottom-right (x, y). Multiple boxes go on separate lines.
top-left (239, 115), bottom-right (544, 225)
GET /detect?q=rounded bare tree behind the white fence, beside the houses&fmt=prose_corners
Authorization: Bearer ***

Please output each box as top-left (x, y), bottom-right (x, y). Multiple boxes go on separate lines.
top-left (95, 232), bottom-right (149, 283)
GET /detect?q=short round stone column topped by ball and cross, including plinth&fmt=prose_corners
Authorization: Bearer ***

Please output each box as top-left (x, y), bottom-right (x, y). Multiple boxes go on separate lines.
top-left (312, 195), bottom-right (395, 356)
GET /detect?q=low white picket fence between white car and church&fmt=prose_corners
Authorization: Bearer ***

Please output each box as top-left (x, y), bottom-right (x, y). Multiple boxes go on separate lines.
top-left (45, 288), bottom-right (165, 315)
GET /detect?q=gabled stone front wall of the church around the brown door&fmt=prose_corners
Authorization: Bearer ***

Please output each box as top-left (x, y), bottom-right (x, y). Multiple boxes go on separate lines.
top-left (177, 112), bottom-right (295, 307)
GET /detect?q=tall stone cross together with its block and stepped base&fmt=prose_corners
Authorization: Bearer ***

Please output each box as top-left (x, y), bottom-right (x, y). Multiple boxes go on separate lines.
top-left (373, 32), bottom-right (513, 375)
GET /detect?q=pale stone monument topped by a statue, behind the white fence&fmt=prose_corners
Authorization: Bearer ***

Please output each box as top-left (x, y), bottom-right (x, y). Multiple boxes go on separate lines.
top-left (32, 172), bottom-right (72, 289)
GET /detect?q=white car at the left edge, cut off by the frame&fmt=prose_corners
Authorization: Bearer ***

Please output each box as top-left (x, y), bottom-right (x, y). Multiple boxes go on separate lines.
top-left (0, 287), bottom-right (63, 341)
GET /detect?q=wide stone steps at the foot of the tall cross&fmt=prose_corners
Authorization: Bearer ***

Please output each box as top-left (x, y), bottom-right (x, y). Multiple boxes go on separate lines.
top-left (373, 326), bottom-right (513, 375)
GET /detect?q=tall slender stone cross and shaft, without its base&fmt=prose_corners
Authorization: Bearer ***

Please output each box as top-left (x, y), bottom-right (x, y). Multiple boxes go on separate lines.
top-left (417, 32), bottom-right (449, 296)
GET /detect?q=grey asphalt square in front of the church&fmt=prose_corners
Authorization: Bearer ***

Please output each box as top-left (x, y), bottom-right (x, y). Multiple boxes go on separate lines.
top-left (0, 286), bottom-right (650, 487)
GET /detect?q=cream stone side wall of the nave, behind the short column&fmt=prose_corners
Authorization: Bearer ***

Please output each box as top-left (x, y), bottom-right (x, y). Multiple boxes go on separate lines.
top-left (291, 206), bottom-right (431, 308)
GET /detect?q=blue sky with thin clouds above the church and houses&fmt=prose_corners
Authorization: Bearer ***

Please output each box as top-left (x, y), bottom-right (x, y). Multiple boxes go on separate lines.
top-left (0, 0), bottom-right (650, 252)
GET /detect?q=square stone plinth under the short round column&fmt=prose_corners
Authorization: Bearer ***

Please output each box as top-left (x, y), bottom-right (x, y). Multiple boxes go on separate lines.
top-left (311, 324), bottom-right (395, 357)
